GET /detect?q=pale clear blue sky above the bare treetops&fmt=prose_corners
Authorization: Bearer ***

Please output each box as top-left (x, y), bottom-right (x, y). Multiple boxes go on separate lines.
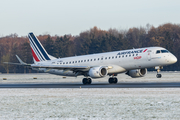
top-left (0, 0), bottom-right (180, 36)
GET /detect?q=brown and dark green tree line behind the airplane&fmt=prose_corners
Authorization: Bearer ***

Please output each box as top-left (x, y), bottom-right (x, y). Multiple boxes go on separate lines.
top-left (0, 23), bottom-right (180, 73)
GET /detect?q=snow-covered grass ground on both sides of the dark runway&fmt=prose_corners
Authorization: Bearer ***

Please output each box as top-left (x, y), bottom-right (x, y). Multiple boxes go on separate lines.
top-left (0, 73), bottom-right (180, 120)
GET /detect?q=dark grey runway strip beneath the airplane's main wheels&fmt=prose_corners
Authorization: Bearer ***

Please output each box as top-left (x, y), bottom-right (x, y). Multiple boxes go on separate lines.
top-left (0, 82), bottom-right (180, 88)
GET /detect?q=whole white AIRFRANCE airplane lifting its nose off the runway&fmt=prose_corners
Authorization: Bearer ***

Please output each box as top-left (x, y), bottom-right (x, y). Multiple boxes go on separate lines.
top-left (5, 32), bottom-right (177, 85)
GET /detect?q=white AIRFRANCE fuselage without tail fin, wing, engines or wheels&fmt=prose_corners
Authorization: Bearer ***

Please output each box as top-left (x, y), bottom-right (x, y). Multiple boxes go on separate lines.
top-left (32, 47), bottom-right (177, 76)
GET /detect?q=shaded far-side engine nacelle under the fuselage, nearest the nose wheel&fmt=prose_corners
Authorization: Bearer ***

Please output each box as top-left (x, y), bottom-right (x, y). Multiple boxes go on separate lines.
top-left (126, 68), bottom-right (147, 78)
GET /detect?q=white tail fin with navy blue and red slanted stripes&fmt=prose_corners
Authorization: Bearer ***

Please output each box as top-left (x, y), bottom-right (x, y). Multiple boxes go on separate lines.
top-left (28, 33), bottom-right (56, 63)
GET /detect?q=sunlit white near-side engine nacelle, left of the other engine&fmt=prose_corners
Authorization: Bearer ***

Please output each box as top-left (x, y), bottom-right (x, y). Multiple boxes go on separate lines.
top-left (88, 67), bottom-right (108, 78)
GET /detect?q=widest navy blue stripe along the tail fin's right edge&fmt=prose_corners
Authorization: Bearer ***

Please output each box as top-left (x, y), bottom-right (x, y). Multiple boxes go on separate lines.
top-left (29, 33), bottom-right (50, 60)
